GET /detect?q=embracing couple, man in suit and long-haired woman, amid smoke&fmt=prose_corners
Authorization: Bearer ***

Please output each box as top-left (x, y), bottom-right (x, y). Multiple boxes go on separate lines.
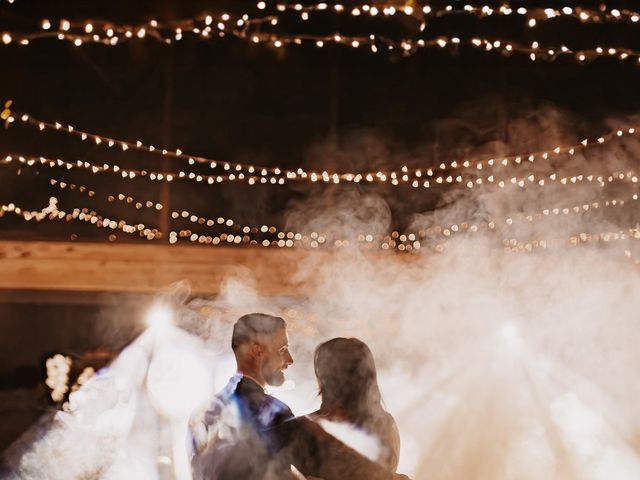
top-left (190, 313), bottom-right (407, 480)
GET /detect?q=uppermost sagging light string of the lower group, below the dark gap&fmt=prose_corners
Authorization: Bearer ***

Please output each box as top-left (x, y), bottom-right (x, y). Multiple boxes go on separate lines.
top-left (9, 108), bottom-right (640, 184)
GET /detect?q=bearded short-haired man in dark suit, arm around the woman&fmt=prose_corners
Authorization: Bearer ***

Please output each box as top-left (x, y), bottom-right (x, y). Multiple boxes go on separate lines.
top-left (191, 313), bottom-right (406, 480)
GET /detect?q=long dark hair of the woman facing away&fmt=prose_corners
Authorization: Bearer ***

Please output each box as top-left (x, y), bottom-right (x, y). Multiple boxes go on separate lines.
top-left (314, 338), bottom-right (387, 429)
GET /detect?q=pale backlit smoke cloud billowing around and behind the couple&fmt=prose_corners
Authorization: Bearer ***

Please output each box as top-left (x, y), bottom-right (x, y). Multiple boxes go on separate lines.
top-left (5, 104), bottom-right (640, 480)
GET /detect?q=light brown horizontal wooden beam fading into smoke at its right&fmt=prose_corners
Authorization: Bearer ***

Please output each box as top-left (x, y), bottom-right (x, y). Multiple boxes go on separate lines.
top-left (0, 241), bottom-right (331, 295)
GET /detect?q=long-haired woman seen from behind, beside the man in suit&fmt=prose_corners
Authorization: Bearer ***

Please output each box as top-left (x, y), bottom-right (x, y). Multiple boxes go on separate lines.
top-left (310, 338), bottom-right (400, 472)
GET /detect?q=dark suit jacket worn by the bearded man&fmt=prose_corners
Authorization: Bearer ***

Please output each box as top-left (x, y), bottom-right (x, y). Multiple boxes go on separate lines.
top-left (191, 376), bottom-right (391, 480)
